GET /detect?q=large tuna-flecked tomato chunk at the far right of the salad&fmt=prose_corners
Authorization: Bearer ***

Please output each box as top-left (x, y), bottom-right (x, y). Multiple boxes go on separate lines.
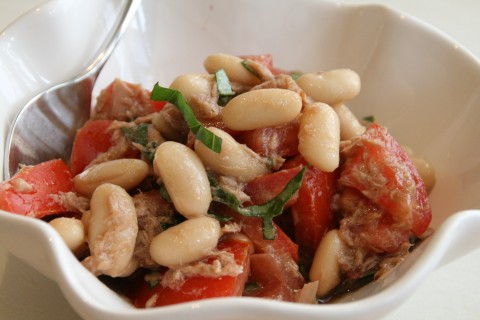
top-left (339, 123), bottom-right (432, 236)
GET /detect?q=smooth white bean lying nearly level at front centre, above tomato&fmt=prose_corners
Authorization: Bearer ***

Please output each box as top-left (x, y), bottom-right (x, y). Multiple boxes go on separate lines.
top-left (149, 217), bottom-right (220, 268)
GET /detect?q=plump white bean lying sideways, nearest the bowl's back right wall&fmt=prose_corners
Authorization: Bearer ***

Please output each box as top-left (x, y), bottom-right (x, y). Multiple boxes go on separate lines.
top-left (297, 69), bottom-right (361, 105)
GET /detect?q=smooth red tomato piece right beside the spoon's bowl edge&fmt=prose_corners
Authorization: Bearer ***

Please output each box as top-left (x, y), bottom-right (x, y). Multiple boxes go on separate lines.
top-left (70, 120), bottom-right (113, 175)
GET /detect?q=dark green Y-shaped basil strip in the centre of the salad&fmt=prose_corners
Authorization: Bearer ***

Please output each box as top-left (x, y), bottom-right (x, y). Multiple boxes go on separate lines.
top-left (212, 167), bottom-right (307, 240)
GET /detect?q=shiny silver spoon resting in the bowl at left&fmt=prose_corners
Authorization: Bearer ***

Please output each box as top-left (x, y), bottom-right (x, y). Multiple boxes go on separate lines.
top-left (3, 0), bottom-right (141, 179)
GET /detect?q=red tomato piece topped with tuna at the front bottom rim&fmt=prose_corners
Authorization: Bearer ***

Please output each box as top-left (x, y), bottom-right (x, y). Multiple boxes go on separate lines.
top-left (131, 236), bottom-right (252, 308)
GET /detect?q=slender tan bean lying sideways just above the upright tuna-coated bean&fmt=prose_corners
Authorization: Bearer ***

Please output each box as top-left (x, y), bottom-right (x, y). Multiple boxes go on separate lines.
top-left (73, 159), bottom-right (149, 196)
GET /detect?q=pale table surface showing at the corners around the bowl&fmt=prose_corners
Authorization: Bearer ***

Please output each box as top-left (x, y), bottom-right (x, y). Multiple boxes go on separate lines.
top-left (0, 0), bottom-right (480, 320)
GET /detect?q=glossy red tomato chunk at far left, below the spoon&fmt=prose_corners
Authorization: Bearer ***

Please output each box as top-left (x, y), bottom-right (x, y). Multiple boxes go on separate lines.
top-left (0, 159), bottom-right (73, 218)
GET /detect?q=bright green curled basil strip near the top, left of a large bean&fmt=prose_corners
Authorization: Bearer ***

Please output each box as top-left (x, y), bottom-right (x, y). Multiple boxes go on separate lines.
top-left (150, 82), bottom-right (222, 153)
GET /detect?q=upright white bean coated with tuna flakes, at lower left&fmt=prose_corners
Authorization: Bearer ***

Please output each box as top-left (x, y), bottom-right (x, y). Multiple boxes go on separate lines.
top-left (82, 183), bottom-right (138, 277)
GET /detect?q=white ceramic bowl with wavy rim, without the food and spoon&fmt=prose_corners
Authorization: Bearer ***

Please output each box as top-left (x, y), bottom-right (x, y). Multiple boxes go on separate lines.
top-left (0, 0), bottom-right (480, 320)
